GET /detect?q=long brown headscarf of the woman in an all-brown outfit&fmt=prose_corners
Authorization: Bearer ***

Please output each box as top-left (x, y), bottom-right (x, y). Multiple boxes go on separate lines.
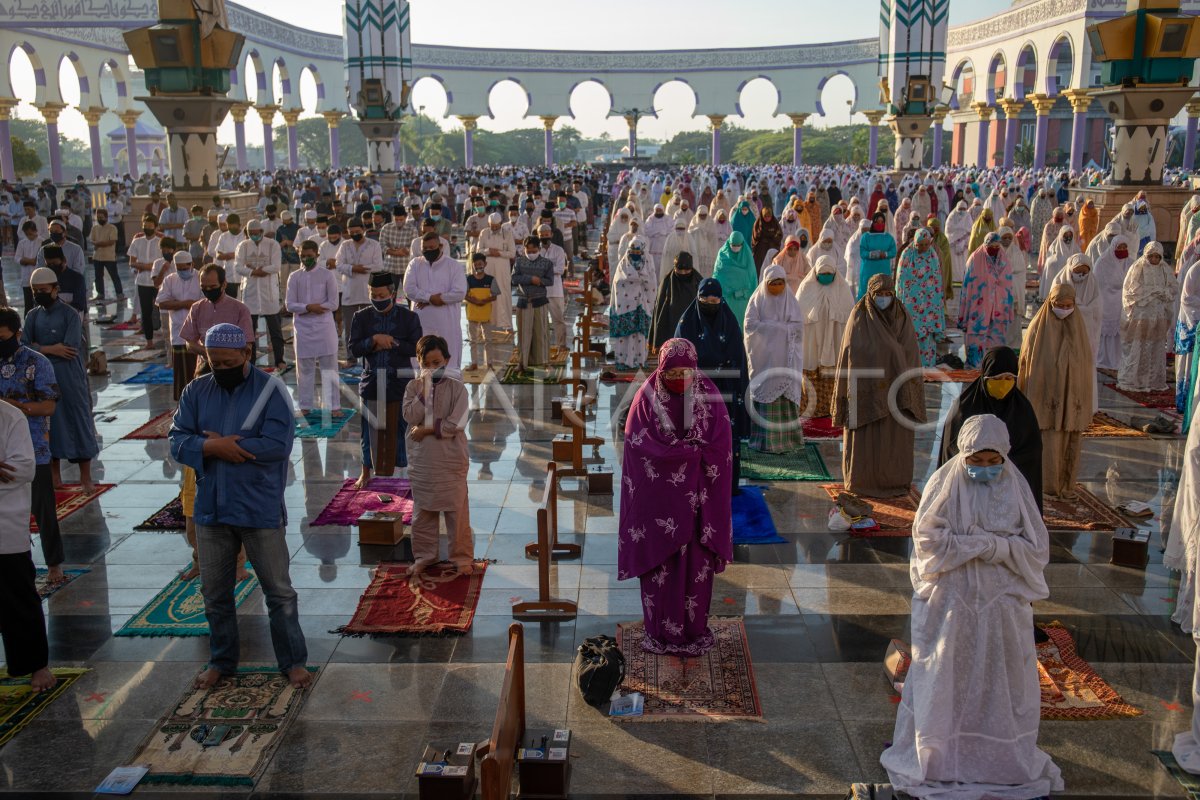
top-left (833, 273), bottom-right (925, 429)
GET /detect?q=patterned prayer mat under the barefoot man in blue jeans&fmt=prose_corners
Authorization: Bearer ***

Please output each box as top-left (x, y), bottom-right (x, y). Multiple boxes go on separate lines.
top-left (126, 667), bottom-right (319, 786)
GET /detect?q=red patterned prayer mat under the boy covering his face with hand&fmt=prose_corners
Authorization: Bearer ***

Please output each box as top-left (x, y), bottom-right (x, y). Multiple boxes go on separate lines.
top-left (330, 560), bottom-right (487, 636)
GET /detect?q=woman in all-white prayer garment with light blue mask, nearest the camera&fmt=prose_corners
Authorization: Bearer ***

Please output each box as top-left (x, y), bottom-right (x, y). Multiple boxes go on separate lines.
top-left (880, 414), bottom-right (1063, 800)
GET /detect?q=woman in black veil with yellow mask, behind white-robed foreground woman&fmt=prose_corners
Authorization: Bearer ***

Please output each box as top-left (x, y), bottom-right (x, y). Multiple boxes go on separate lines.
top-left (937, 347), bottom-right (1042, 511)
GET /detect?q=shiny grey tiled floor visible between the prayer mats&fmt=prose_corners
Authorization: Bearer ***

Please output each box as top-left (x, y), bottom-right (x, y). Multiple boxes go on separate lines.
top-left (0, 251), bottom-right (1194, 798)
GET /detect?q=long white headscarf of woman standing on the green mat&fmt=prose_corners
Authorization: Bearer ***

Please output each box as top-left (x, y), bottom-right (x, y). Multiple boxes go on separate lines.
top-left (745, 264), bottom-right (804, 405)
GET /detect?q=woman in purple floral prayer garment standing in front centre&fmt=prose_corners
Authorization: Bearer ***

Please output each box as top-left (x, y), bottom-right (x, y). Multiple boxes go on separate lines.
top-left (617, 338), bottom-right (733, 656)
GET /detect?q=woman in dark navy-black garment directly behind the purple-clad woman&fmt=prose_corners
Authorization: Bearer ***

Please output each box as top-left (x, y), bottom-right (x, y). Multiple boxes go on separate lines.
top-left (676, 278), bottom-right (750, 495)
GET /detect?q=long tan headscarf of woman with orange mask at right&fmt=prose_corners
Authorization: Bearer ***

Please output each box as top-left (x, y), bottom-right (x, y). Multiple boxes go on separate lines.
top-left (1016, 284), bottom-right (1096, 433)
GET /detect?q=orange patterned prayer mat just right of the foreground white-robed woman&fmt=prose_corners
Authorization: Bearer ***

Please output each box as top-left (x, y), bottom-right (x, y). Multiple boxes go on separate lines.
top-left (1037, 622), bottom-right (1142, 720)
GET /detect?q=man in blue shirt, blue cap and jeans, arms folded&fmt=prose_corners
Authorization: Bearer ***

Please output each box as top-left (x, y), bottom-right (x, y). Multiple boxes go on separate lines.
top-left (169, 323), bottom-right (312, 688)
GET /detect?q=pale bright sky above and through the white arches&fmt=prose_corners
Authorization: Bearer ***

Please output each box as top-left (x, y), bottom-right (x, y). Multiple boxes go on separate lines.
top-left (11, 0), bottom-right (1012, 145)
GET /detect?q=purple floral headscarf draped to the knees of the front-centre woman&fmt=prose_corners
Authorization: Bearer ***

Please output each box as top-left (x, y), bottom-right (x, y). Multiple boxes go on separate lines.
top-left (617, 338), bottom-right (733, 581)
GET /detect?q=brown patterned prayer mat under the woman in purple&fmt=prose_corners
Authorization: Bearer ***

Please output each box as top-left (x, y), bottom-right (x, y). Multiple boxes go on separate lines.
top-left (617, 616), bottom-right (762, 722)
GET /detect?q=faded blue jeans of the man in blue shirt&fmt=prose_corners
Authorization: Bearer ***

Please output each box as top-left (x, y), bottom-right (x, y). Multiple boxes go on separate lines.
top-left (196, 525), bottom-right (308, 675)
